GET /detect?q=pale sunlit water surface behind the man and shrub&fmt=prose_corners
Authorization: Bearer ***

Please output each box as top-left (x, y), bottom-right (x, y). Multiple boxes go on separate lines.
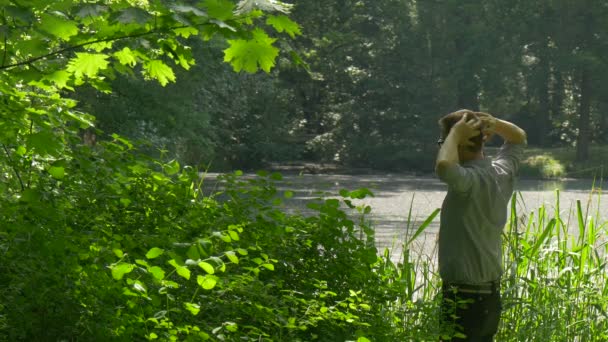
top-left (207, 174), bottom-right (608, 261)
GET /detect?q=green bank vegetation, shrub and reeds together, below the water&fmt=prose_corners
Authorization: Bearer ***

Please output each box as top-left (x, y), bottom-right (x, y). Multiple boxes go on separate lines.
top-left (0, 146), bottom-right (608, 341)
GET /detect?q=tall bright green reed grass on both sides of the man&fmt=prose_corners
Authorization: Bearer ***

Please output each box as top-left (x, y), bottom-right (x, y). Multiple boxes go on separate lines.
top-left (384, 190), bottom-right (608, 342)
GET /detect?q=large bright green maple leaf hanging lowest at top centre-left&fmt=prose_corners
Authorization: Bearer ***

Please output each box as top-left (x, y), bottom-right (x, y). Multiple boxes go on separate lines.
top-left (224, 28), bottom-right (279, 73)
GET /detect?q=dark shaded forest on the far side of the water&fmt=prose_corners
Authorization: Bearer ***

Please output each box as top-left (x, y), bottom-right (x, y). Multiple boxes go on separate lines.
top-left (78, 0), bottom-right (608, 171)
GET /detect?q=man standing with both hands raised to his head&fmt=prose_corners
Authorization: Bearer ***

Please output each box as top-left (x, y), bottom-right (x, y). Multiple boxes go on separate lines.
top-left (435, 110), bottom-right (526, 341)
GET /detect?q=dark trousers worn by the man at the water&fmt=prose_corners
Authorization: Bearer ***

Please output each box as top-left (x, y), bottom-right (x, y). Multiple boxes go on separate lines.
top-left (441, 282), bottom-right (502, 342)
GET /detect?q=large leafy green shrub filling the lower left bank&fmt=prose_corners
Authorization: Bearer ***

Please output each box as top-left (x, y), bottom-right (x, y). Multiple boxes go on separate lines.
top-left (0, 130), bottom-right (414, 341)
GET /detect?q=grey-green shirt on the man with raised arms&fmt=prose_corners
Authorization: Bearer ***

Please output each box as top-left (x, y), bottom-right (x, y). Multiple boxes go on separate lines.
top-left (439, 144), bottom-right (522, 284)
